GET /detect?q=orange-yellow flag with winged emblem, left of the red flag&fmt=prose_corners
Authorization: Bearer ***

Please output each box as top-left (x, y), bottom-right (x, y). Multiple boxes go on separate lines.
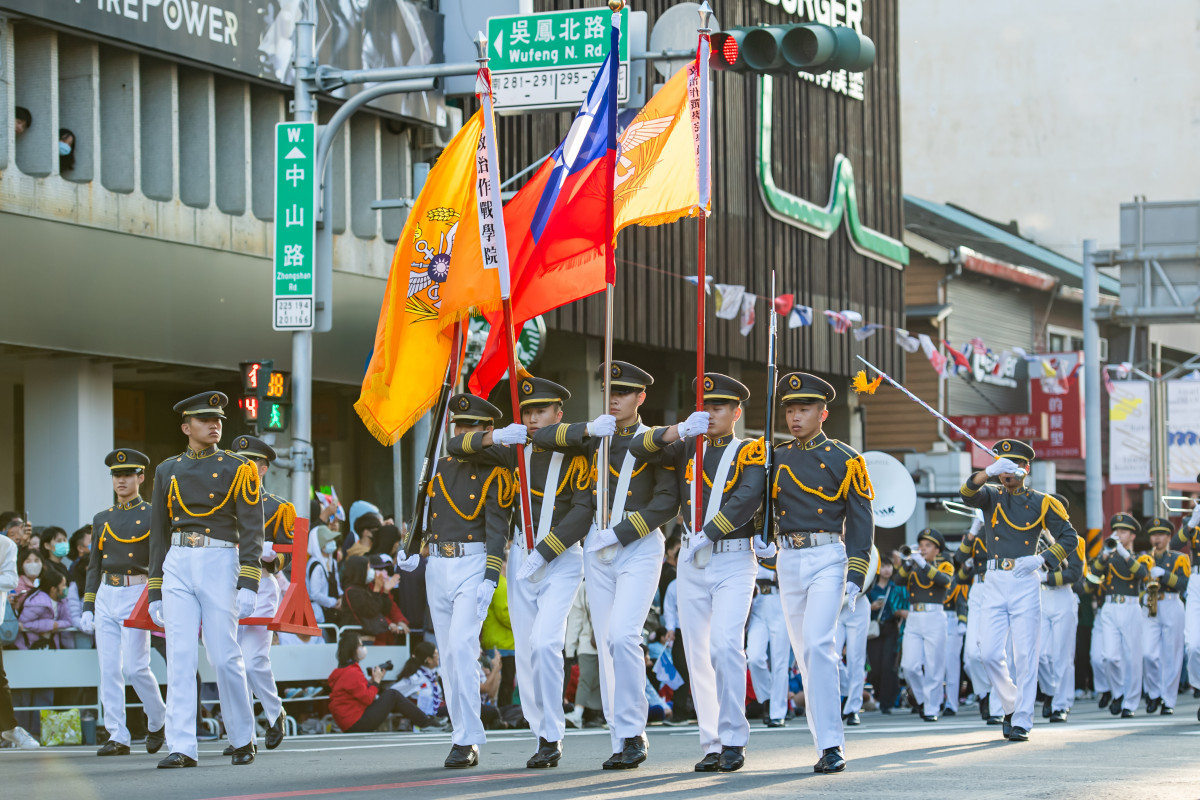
top-left (354, 107), bottom-right (489, 445)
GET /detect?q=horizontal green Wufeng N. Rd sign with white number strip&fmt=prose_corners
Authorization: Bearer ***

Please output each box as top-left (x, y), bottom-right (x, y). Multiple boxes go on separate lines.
top-left (487, 6), bottom-right (629, 112)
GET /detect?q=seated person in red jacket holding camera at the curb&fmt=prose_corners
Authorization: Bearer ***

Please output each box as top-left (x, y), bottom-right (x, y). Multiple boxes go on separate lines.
top-left (328, 631), bottom-right (449, 733)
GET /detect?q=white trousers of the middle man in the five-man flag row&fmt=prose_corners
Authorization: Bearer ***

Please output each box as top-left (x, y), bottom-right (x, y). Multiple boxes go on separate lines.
top-left (583, 524), bottom-right (667, 753)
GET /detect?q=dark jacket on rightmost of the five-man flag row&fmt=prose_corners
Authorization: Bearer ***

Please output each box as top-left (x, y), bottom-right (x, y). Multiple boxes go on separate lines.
top-left (770, 432), bottom-right (875, 589)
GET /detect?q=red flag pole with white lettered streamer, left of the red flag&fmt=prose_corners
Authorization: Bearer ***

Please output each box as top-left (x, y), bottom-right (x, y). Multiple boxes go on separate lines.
top-left (475, 31), bottom-right (533, 551)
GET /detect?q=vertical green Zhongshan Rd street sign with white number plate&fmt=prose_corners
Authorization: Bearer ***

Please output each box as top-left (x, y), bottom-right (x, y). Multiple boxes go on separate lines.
top-left (272, 121), bottom-right (317, 331)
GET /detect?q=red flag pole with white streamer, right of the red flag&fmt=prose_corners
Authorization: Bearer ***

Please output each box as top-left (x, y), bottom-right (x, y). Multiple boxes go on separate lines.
top-left (692, 0), bottom-right (713, 534)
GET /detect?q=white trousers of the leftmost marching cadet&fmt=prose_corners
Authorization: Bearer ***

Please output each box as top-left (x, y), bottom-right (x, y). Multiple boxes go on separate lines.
top-left (94, 583), bottom-right (167, 745)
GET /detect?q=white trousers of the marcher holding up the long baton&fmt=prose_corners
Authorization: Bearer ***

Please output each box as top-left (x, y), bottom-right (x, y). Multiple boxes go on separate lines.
top-left (974, 570), bottom-right (1042, 730)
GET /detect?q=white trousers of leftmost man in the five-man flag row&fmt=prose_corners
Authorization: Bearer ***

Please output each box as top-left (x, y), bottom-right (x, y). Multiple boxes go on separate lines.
top-left (425, 553), bottom-right (487, 745)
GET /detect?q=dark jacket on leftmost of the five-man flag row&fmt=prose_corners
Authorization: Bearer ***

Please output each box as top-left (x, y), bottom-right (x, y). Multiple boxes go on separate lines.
top-left (425, 448), bottom-right (516, 583)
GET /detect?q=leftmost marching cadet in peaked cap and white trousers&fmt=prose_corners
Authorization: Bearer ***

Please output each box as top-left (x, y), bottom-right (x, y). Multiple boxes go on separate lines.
top-left (79, 449), bottom-right (167, 756)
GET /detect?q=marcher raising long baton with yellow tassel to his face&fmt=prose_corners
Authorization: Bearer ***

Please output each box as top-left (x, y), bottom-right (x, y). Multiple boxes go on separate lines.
top-left (959, 439), bottom-right (1078, 741)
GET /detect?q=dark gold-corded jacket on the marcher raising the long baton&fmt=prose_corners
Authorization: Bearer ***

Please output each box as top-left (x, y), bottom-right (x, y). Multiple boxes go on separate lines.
top-left (959, 479), bottom-right (1079, 570)
